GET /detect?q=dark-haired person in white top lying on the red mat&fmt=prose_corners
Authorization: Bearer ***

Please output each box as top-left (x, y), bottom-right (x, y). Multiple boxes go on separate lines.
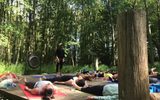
top-left (24, 79), bottom-right (58, 100)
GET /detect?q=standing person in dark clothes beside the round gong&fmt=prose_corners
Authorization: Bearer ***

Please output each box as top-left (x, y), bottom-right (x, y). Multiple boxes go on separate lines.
top-left (56, 43), bottom-right (65, 75)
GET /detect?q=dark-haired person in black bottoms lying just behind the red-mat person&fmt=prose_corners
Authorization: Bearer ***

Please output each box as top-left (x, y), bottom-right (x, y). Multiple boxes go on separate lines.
top-left (43, 75), bottom-right (88, 87)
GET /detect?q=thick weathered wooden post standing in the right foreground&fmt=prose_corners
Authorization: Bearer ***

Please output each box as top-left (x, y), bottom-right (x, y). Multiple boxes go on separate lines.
top-left (117, 10), bottom-right (149, 100)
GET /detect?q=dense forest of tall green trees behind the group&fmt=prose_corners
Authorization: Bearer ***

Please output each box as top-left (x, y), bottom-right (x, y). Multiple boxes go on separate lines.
top-left (0, 0), bottom-right (160, 66)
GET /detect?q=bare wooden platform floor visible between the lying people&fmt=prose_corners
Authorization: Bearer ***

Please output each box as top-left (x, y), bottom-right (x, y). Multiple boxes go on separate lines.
top-left (0, 76), bottom-right (105, 100)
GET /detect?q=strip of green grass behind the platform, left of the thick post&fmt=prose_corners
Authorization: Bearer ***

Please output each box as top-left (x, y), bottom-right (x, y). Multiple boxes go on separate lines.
top-left (0, 62), bottom-right (114, 75)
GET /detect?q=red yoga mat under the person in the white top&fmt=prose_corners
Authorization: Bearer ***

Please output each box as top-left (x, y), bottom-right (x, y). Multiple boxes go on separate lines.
top-left (19, 84), bottom-right (66, 100)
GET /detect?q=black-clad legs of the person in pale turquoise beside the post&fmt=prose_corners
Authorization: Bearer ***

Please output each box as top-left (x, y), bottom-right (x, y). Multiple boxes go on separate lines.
top-left (81, 85), bottom-right (104, 96)
